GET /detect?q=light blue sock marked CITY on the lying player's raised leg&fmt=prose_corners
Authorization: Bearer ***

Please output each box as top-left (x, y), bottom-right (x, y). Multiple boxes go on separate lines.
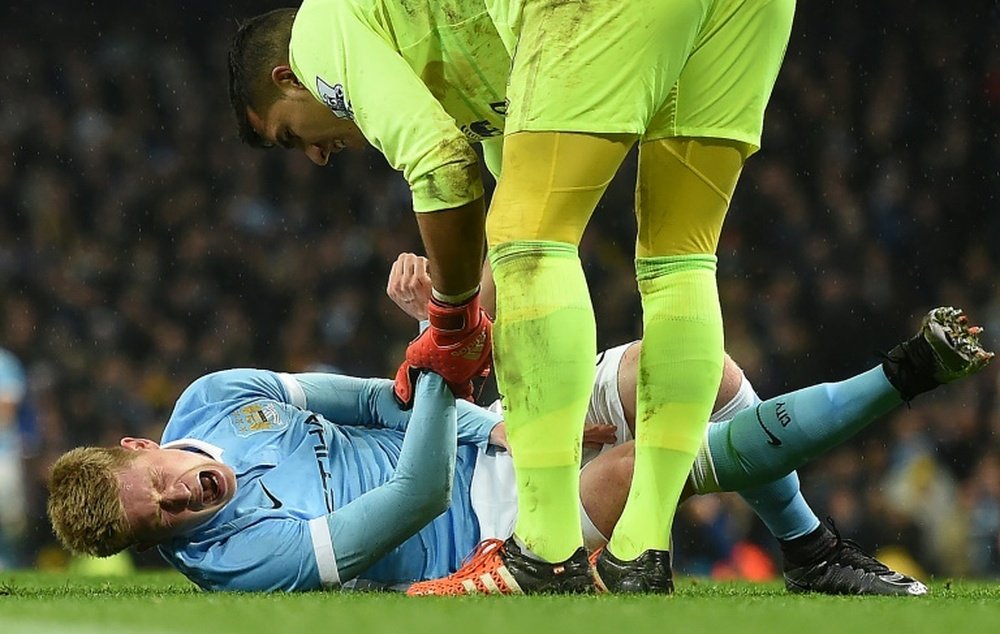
top-left (708, 366), bottom-right (903, 494)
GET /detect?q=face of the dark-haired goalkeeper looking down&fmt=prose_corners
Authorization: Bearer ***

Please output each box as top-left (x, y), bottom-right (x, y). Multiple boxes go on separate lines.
top-left (247, 75), bottom-right (368, 165)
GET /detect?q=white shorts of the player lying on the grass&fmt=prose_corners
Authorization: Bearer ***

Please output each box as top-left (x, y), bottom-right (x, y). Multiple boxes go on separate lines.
top-left (470, 342), bottom-right (635, 550)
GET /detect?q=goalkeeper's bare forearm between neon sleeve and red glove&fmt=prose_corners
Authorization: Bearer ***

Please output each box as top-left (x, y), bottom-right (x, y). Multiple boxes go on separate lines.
top-left (417, 198), bottom-right (486, 295)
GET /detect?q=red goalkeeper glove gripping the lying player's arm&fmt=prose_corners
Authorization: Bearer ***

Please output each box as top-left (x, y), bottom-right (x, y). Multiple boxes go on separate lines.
top-left (394, 293), bottom-right (493, 408)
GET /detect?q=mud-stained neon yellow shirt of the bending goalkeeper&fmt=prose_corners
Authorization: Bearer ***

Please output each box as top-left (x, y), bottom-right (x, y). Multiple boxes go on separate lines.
top-left (289, 0), bottom-right (510, 212)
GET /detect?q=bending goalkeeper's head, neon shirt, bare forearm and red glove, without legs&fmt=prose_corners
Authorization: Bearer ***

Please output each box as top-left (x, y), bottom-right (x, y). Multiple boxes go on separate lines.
top-left (229, 0), bottom-right (510, 403)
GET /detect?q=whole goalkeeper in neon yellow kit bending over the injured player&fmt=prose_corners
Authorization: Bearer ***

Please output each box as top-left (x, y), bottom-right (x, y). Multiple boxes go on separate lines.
top-left (230, 0), bottom-right (794, 593)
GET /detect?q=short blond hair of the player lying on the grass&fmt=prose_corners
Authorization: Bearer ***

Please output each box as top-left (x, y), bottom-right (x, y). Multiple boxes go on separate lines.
top-left (48, 447), bottom-right (136, 557)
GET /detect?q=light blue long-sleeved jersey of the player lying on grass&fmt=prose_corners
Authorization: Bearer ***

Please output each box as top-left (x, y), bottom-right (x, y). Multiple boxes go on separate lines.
top-left (159, 369), bottom-right (500, 590)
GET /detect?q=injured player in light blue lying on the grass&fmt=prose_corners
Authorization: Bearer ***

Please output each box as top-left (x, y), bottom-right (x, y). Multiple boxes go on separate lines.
top-left (48, 272), bottom-right (992, 595)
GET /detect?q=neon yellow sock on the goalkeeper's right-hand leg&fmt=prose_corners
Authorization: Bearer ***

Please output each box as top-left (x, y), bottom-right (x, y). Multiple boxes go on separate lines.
top-left (608, 255), bottom-right (723, 560)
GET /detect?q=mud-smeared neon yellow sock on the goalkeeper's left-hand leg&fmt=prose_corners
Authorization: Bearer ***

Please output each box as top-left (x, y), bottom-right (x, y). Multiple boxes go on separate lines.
top-left (489, 241), bottom-right (597, 562)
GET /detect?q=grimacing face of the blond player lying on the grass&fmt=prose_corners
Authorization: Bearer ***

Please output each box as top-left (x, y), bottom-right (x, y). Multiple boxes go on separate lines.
top-left (118, 438), bottom-right (236, 547)
